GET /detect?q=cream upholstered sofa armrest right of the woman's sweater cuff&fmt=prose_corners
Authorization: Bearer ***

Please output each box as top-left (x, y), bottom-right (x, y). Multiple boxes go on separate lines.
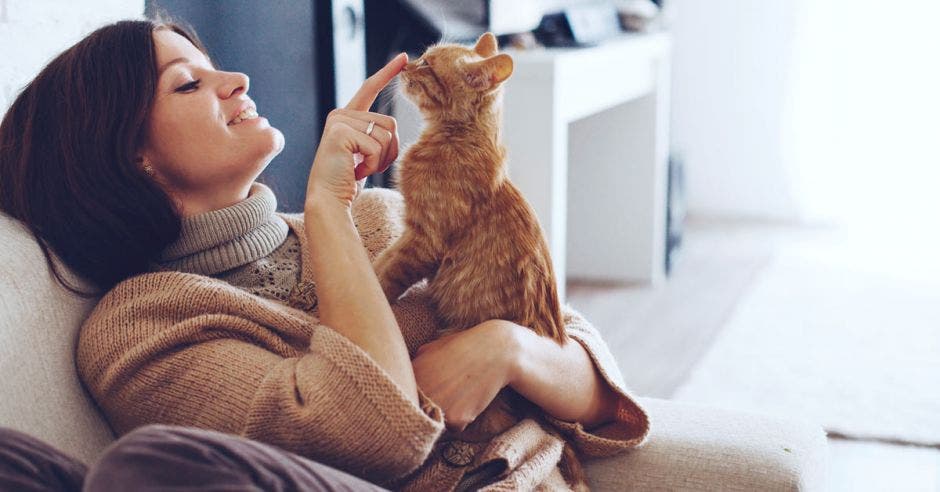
top-left (585, 398), bottom-right (829, 491)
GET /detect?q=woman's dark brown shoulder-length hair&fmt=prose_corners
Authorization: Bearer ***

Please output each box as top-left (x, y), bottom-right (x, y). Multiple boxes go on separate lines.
top-left (0, 20), bottom-right (205, 297)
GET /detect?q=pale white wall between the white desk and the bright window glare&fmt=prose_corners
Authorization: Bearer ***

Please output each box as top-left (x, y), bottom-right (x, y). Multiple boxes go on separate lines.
top-left (671, 0), bottom-right (798, 219)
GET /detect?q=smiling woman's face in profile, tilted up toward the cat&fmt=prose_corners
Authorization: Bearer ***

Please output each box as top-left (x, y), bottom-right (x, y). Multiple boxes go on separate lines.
top-left (140, 29), bottom-right (284, 216)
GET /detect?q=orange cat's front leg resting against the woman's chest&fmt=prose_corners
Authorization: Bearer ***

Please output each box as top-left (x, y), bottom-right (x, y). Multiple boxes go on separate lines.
top-left (372, 230), bottom-right (435, 302)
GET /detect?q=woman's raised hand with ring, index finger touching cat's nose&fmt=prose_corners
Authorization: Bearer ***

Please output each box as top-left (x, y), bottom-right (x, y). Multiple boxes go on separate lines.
top-left (306, 53), bottom-right (408, 209)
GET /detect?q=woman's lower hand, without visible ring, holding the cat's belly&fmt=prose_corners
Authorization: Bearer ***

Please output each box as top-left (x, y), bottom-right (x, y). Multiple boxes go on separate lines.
top-left (412, 320), bottom-right (519, 430)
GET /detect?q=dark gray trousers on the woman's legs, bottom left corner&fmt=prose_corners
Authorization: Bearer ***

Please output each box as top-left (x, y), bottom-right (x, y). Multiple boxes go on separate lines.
top-left (0, 425), bottom-right (384, 491)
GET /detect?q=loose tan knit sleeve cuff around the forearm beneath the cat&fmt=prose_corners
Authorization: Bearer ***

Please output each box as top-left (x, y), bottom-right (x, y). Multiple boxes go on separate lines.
top-left (543, 306), bottom-right (650, 457)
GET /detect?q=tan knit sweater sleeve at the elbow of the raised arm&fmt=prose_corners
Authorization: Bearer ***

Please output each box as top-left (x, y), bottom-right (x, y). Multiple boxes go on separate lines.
top-left (241, 316), bottom-right (444, 483)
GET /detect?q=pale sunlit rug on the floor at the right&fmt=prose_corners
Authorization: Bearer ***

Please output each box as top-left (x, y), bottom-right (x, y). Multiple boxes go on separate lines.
top-left (674, 246), bottom-right (940, 446)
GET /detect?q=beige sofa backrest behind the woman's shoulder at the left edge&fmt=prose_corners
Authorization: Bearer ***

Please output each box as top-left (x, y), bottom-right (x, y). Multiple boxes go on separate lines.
top-left (0, 213), bottom-right (113, 463)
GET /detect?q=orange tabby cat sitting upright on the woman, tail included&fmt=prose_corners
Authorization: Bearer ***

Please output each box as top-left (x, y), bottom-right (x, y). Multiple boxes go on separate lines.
top-left (375, 33), bottom-right (584, 488)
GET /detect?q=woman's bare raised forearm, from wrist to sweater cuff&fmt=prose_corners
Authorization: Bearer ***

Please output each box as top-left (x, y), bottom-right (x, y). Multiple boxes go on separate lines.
top-left (304, 200), bottom-right (418, 403)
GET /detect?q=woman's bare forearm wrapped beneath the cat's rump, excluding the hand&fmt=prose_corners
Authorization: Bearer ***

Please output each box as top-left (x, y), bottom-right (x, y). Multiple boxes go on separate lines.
top-left (510, 324), bottom-right (618, 427)
